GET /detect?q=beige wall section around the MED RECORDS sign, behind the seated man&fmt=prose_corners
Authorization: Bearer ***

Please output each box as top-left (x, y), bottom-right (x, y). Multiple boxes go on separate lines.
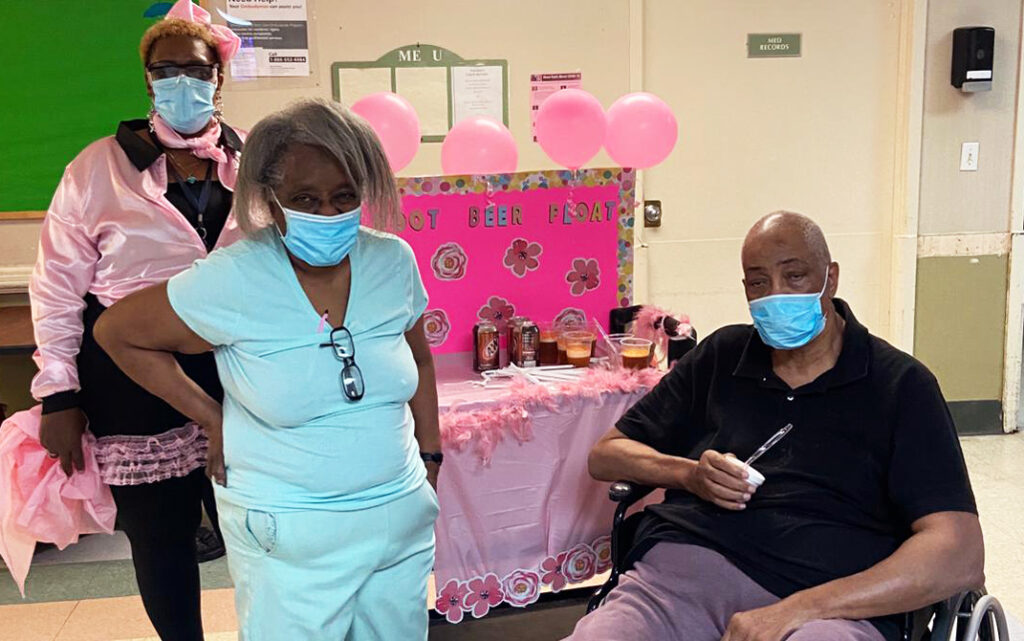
top-left (644, 0), bottom-right (900, 336)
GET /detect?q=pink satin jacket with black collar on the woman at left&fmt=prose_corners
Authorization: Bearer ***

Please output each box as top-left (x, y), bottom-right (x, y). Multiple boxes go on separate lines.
top-left (29, 124), bottom-right (242, 399)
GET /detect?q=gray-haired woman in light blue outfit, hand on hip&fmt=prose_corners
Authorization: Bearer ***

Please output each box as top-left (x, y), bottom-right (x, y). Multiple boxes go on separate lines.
top-left (95, 100), bottom-right (441, 641)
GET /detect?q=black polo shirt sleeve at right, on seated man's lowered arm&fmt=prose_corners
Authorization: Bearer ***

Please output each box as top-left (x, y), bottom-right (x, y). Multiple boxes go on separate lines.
top-left (889, 362), bottom-right (978, 526)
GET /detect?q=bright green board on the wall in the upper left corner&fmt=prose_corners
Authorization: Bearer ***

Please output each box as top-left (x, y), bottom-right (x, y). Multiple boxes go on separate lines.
top-left (0, 0), bottom-right (155, 212)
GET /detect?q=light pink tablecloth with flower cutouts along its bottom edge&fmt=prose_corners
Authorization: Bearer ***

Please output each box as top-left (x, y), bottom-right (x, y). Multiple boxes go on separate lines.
top-left (434, 354), bottom-right (644, 622)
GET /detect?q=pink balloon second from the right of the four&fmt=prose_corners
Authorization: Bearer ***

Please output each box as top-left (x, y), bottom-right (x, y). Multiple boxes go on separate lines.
top-left (537, 89), bottom-right (606, 169)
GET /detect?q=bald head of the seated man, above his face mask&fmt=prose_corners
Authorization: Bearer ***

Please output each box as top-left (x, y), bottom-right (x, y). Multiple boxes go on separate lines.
top-left (742, 211), bottom-right (839, 300)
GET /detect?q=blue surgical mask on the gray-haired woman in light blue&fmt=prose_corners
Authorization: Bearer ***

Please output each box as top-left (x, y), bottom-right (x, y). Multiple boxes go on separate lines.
top-left (273, 196), bottom-right (361, 267)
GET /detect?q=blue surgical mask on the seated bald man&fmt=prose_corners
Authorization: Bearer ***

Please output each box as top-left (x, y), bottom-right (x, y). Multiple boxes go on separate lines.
top-left (750, 271), bottom-right (828, 349)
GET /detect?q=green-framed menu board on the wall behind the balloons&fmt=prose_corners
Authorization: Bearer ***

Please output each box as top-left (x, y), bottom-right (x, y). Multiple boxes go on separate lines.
top-left (331, 43), bottom-right (509, 142)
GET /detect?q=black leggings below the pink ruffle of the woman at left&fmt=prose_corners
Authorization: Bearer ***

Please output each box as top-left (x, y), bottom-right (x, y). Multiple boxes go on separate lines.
top-left (111, 468), bottom-right (219, 641)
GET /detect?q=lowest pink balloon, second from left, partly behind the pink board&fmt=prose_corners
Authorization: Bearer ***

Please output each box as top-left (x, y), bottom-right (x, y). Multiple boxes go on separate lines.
top-left (441, 116), bottom-right (519, 175)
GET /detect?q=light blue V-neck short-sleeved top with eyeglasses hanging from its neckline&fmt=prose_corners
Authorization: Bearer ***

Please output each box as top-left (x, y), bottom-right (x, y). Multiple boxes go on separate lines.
top-left (167, 227), bottom-right (427, 511)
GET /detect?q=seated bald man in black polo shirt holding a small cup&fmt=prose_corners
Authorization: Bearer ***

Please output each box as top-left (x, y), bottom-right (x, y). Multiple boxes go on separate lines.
top-left (571, 212), bottom-right (984, 641)
